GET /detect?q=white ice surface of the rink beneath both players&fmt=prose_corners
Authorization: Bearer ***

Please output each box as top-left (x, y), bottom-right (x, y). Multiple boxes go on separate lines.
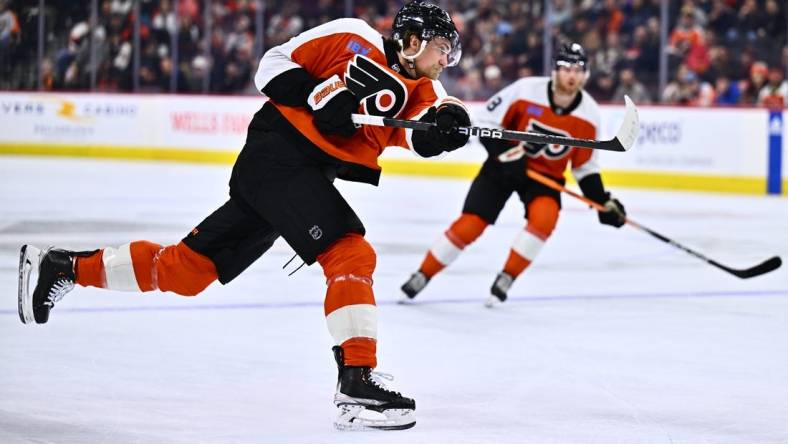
top-left (0, 157), bottom-right (788, 443)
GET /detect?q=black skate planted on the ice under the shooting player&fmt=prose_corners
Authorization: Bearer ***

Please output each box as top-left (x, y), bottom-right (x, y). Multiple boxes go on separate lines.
top-left (333, 347), bottom-right (416, 430)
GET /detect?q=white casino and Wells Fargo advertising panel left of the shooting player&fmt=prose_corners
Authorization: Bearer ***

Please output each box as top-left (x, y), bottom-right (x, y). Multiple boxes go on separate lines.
top-left (0, 93), bottom-right (264, 151)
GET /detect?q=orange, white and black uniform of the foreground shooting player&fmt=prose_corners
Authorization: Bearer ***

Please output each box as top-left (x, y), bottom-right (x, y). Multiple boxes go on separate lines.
top-left (71, 19), bottom-right (464, 367)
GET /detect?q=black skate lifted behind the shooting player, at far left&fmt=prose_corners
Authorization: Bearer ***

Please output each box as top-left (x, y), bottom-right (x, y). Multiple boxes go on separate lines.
top-left (19, 245), bottom-right (93, 324)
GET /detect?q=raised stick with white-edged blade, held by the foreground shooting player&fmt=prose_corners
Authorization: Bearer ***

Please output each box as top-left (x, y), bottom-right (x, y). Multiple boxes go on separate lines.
top-left (353, 96), bottom-right (640, 151)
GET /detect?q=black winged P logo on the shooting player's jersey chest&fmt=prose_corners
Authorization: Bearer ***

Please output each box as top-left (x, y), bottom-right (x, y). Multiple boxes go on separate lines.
top-left (345, 55), bottom-right (408, 118)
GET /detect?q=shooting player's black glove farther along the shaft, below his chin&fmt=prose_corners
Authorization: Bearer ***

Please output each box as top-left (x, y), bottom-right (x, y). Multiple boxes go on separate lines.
top-left (412, 99), bottom-right (471, 157)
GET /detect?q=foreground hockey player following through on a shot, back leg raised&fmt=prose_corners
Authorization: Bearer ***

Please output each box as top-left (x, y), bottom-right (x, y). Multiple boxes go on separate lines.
top-left (19, 2), bottom-right (470, 429)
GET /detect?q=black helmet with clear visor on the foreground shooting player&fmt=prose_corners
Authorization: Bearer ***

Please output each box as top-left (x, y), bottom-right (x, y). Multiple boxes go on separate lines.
top-left (391, 0), bottom-right (462, 66)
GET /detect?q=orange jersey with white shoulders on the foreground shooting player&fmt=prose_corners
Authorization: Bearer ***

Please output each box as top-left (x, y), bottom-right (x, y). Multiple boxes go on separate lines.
top-left (255, 18), bottom-right (446, 184)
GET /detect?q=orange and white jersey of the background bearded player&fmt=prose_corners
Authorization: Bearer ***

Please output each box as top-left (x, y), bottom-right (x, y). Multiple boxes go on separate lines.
top-left (478, 77), bottom-right (600, 182)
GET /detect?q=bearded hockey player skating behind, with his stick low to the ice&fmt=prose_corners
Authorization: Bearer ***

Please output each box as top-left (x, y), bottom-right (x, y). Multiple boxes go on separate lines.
top-left (402, 43), bottom-right (625, 306)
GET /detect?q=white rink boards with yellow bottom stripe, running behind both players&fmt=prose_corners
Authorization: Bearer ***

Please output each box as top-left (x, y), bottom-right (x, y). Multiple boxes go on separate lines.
top-left (0, 93), bottom-right (786, 193)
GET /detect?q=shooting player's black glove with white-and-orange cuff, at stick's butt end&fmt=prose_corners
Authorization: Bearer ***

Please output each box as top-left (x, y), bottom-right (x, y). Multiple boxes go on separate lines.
top-left (307, 74), bottom-right (358, 137)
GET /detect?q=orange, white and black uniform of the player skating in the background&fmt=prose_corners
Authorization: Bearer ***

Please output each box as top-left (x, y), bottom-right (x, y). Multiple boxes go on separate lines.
top-left (419, 77), bottom-right (607, 279)
